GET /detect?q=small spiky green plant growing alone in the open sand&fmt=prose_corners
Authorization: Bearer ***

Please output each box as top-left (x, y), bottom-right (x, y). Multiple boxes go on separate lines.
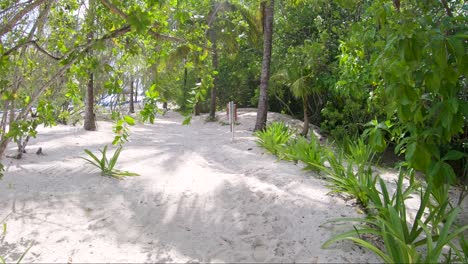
top-left (82, 145), bottom-right (139, 179)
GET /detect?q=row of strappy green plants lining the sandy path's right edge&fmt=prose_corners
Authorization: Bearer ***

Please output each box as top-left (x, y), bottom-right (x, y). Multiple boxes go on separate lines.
top-left (256, 123), bottom-right (468, 263)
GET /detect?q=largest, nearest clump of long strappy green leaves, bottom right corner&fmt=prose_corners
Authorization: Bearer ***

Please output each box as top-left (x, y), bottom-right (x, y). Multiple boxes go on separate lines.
top-left (323, 170), bottom-right (468, 263)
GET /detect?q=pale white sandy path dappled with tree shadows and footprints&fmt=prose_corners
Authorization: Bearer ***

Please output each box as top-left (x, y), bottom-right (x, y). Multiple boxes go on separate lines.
top-left (0, 109), bottom-right (378, 262)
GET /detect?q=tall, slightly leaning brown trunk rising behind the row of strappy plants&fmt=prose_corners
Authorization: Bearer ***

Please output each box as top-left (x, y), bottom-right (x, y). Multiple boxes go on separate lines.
top-left (254, 0), bottom-right (275, 131)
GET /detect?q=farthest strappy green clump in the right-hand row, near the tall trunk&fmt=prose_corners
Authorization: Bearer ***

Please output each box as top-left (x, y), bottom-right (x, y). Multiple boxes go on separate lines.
top-left (255, 122), bottom-right (292, 156)
